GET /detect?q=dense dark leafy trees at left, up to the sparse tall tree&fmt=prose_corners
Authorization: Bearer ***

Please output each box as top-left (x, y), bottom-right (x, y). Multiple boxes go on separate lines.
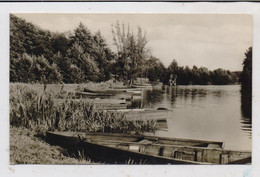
top-left (10, 15), bottom-right (114, 83)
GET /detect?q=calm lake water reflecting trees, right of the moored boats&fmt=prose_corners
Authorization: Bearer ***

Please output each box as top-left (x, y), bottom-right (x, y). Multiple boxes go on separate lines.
top-left (143, 85), bottom-right (251, 150)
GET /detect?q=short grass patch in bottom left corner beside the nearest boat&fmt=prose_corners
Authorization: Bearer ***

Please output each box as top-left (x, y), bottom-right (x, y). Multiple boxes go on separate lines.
top-left (10, 127), bottom-right (93, 164)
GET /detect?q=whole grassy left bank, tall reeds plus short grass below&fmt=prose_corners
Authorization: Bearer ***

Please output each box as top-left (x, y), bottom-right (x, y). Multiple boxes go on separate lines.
top-left (10, 84), bottom-right (157, 164)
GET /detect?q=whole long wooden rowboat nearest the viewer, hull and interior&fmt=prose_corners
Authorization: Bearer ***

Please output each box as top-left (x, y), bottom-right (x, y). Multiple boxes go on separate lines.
top-left (46, 132), bottom-right (251, 164)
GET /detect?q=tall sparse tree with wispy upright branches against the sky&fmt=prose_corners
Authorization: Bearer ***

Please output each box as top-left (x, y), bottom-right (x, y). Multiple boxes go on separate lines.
top-left (112, 21), bottom-right (148, 85)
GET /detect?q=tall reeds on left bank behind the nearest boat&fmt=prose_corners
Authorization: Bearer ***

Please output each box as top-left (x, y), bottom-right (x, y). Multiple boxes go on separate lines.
top-left (10, 84), bottom-right (157, 133)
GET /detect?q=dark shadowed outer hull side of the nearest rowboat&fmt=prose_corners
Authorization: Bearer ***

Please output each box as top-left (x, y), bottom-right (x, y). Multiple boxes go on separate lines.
top-left (47, 132), bottom-right (206, 164)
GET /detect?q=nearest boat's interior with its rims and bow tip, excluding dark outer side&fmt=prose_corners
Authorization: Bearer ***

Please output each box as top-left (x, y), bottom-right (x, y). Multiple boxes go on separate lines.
top-left (47, 132), bottom-right (251, 164)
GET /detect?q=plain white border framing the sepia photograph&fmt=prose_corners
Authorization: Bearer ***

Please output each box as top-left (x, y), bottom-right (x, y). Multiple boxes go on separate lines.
top-left (0, 2), bottom-right (260, 177)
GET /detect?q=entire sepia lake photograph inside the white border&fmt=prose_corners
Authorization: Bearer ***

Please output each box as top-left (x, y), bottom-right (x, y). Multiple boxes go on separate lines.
top-left (9, 13), bottom-right (253, 165)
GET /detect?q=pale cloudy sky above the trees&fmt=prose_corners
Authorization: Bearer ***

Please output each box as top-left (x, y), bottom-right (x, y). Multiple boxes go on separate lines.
top-left (15, 13), bottom-right (253, 71)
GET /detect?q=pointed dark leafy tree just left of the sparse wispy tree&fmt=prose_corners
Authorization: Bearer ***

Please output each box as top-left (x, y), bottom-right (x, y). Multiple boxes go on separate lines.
top-left (70, 23), bottom-right (113, 81)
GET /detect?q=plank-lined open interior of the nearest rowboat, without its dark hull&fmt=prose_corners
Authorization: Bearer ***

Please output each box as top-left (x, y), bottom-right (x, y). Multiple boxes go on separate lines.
top-left (87, 139), bottom-right (251, 164)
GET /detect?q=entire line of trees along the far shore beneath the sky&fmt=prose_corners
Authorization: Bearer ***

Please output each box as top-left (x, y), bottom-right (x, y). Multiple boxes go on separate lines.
top-left (10, 14), bottom-right (248, 85)
